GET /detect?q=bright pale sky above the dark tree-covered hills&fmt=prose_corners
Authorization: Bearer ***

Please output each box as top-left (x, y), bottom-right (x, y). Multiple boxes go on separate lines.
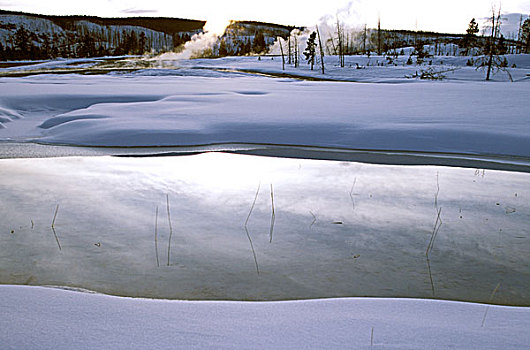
top-left (0, 0), bottom-right (530, 33)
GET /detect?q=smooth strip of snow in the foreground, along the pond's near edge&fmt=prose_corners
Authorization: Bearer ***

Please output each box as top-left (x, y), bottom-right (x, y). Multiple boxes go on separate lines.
top-left (0, 286), bottom-right (530, 350)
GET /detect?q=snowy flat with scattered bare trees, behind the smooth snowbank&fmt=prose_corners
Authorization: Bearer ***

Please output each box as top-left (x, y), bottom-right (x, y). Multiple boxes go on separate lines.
top-left (175, 50), bottom-right (530, 83)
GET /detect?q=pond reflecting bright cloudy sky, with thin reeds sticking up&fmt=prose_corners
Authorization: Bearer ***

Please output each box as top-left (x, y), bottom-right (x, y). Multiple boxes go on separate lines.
top-left (0, 153), bottom-right (530, 306)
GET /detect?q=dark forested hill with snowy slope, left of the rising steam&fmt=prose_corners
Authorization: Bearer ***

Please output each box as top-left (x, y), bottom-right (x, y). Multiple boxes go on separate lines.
top-left (0, 10), bottom-right (206, 60)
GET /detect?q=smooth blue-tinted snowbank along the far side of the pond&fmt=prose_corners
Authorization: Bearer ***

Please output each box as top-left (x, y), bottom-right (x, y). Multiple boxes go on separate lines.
top-left (0, 57), bottom-right (530, 157)
